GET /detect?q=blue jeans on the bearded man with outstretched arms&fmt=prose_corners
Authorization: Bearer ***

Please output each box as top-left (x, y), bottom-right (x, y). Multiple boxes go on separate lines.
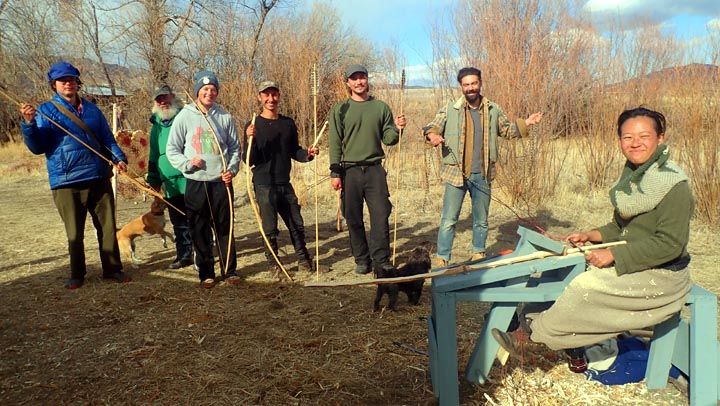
top-left (437, 173), bottom-right (490, 261)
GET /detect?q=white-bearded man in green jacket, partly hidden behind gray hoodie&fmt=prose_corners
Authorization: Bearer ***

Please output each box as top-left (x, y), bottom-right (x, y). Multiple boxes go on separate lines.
top-left (147, 84), bottom-right (193, 269)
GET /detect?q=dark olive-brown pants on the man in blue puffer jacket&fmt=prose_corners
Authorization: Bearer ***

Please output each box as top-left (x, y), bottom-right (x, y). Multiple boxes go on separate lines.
top-left (52, 179), bottom-right (122, 279)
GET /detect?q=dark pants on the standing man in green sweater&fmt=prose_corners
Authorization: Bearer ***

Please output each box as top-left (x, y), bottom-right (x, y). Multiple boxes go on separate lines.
top-left (342, 164), bottom-right (392, 264)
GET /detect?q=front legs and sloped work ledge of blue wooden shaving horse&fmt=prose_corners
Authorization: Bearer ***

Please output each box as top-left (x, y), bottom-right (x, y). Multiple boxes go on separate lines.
top-left (428, 227), bottom-right (585, 406)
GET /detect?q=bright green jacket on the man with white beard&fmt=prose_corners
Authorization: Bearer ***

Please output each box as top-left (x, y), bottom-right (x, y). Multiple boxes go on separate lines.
top-left (147, 115), bottom-right (185, 198)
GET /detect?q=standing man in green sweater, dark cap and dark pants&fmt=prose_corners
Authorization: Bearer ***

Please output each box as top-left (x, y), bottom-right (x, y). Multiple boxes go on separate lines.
top-left (328, 65), bottom-right (405, 274)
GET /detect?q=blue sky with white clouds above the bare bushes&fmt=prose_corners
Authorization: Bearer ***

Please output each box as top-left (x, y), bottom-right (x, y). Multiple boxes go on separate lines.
top-left (304, 0), bottom-right (720, 85)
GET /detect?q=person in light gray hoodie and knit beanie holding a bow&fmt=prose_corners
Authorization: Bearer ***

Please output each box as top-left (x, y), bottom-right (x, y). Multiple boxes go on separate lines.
top-left (166, 71), bottom-right (240, 288)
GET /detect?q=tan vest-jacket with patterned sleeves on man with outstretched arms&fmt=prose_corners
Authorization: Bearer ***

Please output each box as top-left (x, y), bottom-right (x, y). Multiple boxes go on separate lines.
top-left (423, 96), bottom-right (528, 181)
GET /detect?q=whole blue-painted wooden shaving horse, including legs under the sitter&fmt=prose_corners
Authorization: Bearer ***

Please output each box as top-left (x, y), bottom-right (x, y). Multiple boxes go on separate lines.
top-left (428, 227), bottom-right (720, 406)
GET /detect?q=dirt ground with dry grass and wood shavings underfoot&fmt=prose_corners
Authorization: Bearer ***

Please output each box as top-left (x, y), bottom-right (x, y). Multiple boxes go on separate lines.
top-left (0, 164), bottom-right (720, 405)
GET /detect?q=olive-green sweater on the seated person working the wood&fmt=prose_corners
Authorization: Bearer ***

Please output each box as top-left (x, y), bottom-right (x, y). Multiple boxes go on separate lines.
top-left (598, 181), bottom-right (695, 275)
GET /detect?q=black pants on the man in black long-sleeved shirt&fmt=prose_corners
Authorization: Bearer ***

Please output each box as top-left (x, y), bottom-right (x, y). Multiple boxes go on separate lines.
top-left (255, 183), bottom-right (310, 264)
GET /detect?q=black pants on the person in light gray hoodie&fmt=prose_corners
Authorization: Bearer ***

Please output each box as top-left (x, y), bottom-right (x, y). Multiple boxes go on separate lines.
top-left (185, 179), bottom-right (237, 281)
